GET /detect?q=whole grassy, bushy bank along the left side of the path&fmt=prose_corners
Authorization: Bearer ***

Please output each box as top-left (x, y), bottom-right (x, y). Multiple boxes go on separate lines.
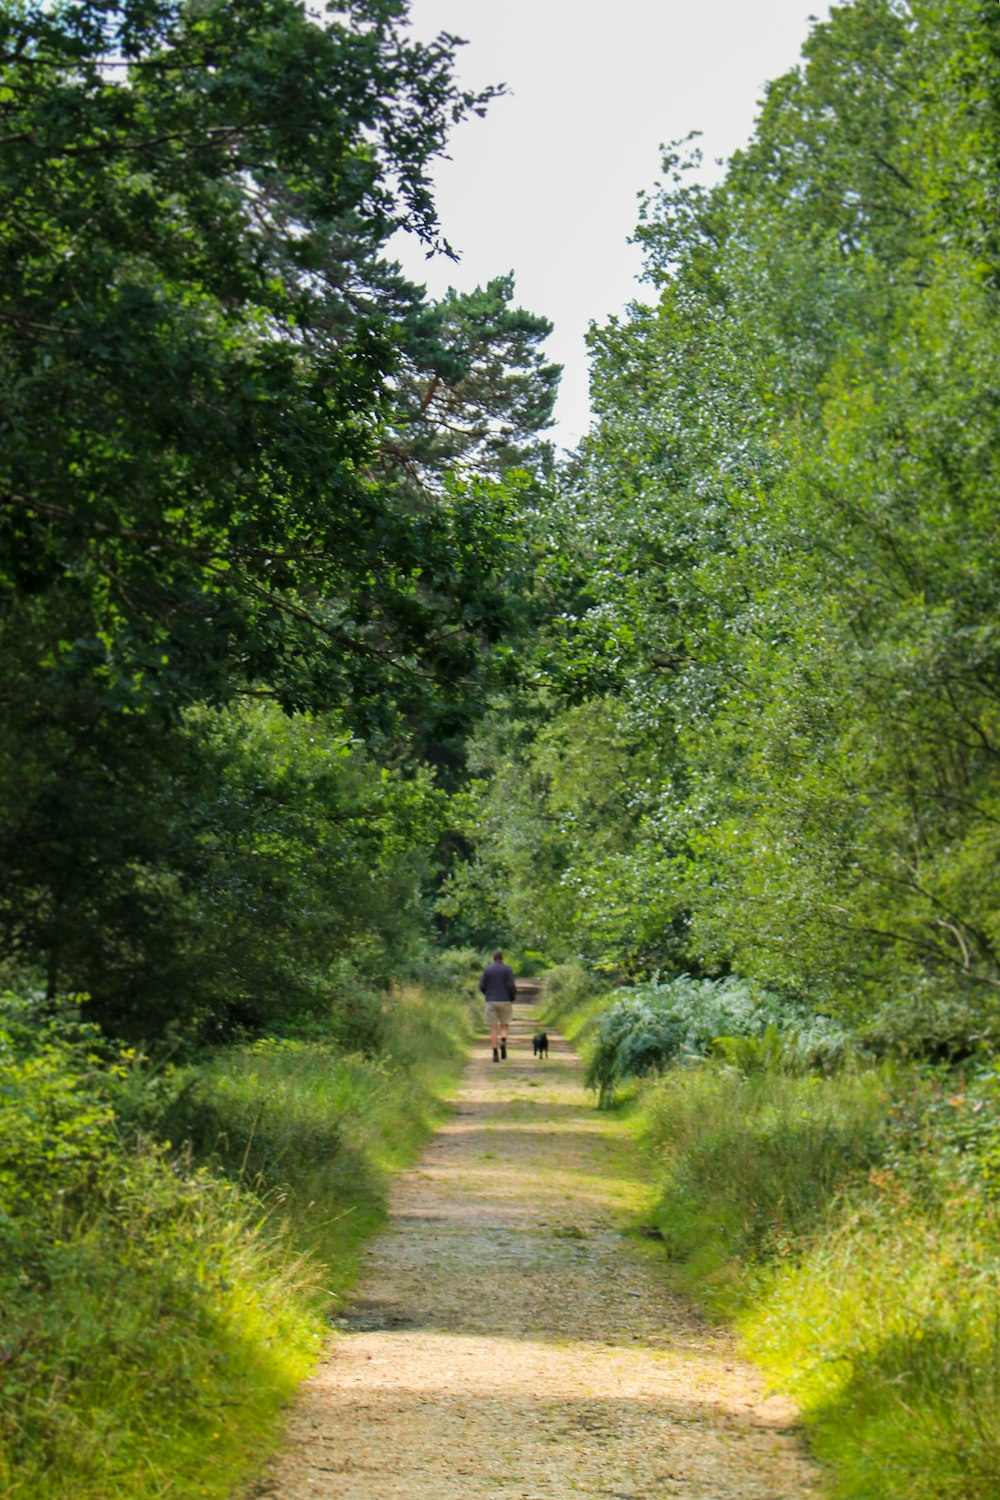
top-left (0, 989), bottom-right (469, 1500)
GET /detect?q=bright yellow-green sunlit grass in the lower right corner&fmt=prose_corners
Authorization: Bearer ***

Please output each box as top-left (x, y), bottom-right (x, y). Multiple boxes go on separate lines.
top-left (742, 1184), bottom-right (1000, 1500)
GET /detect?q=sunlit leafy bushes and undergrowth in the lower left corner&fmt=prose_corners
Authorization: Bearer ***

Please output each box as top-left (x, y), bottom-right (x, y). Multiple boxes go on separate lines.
top-left (0, 1001), bottom-right (318, 1496)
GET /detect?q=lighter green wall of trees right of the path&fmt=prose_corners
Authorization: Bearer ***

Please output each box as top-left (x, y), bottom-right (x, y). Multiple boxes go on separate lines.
top-left (456, 0), bottom-right (1000, 1053)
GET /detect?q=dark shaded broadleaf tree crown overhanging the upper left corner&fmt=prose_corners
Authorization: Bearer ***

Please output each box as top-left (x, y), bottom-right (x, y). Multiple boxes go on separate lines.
top-left (0, 0), bottom-right (521, 713)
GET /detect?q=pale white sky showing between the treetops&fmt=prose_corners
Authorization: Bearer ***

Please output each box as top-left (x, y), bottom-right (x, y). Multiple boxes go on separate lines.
top-left (393, 0), bottom-right (828, 447)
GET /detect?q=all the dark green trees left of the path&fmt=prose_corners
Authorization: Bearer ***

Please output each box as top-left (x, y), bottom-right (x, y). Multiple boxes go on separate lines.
top-left (0, 0), bottom-right (558, 1038)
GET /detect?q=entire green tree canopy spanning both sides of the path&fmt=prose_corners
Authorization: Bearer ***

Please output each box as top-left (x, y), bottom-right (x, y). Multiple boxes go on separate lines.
top-left (0, 0), bottom-right (1000, 1068)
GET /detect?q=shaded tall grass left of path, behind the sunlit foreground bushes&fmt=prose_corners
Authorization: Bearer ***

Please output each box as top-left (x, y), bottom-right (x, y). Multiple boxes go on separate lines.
top-left (160, 986), bottom-right (471, 1293)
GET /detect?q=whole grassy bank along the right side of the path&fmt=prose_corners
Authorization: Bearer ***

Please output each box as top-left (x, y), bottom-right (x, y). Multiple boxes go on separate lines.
top-left (559, 986), bottom-right (1000, 1500)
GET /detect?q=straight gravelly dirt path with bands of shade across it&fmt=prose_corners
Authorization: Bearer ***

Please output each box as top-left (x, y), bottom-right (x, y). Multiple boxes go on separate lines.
top-left (253, 1005), bottom-right (819, 1500)
